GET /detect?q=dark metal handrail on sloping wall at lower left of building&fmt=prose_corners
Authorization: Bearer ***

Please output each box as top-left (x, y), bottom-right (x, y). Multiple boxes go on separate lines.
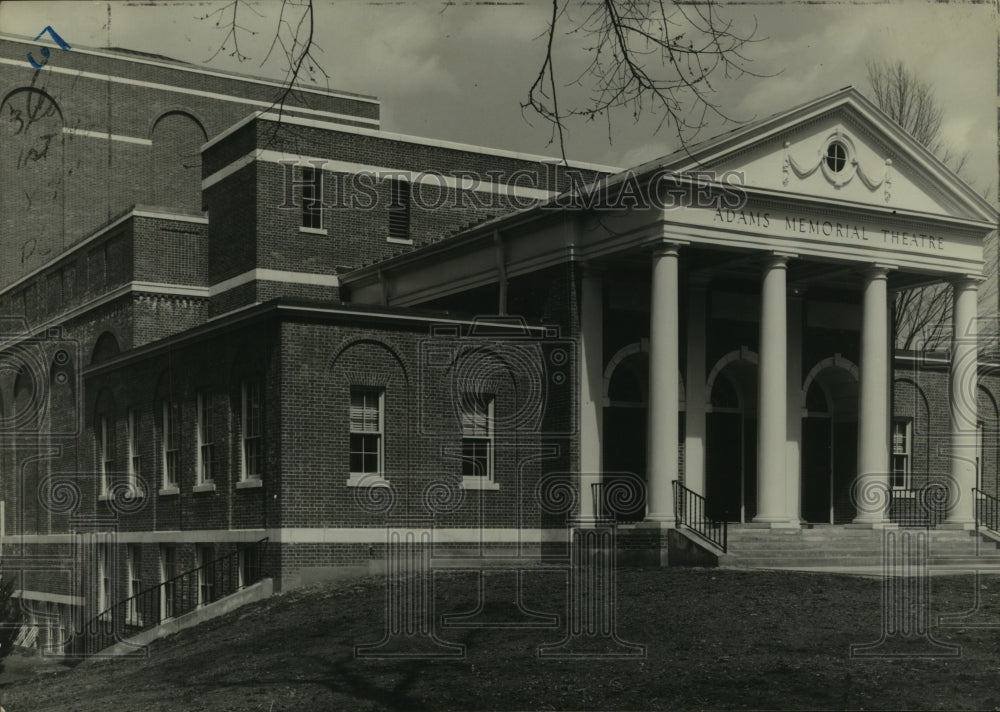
top-left (76, 538), bottom-right (268, 655)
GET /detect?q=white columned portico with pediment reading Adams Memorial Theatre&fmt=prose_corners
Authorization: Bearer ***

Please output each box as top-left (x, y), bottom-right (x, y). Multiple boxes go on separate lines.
top-left (340, 88), bottom-right (996, 544)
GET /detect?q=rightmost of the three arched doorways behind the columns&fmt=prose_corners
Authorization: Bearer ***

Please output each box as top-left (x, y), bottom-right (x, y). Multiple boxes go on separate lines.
top-left (801, 362), bottom-right (858, 524)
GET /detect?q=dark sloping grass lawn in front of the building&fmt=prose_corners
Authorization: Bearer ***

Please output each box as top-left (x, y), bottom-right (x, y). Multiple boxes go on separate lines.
top-left (2, 569), bottom-right (1000, 712)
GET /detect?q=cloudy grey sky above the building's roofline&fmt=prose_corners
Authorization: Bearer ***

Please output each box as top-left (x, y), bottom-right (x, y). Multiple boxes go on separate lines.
top-left (0, 0), bottom-right (997, 196)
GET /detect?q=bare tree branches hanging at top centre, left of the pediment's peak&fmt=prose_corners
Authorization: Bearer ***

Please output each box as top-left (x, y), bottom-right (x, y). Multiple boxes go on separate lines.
top-left (521, 0), bottom-right (764, 161)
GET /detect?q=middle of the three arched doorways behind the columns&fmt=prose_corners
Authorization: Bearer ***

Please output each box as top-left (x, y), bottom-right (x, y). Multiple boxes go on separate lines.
top-left (705, 348), bottom-right (757, 522)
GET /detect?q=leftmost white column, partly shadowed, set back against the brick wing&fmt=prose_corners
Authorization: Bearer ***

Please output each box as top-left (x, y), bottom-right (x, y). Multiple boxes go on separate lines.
top-left (577, 266), bottom-right (604, 517)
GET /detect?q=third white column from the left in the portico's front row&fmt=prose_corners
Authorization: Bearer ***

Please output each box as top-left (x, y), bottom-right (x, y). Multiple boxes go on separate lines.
top-left (854, 266), bottom-right (890, 526)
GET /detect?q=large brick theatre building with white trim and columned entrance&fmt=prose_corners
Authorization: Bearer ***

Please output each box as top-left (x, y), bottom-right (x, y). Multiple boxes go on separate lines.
top-left (0, 37), bottom-right (1000, 647)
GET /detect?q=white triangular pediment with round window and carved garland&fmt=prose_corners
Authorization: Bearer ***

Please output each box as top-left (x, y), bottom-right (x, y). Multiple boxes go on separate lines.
top-left (660, 87), bottom-right (996, 222)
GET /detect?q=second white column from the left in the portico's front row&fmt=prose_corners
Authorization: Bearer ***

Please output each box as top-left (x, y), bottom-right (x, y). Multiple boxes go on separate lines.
top-left (754, 255), bottom-right (798, 526)
